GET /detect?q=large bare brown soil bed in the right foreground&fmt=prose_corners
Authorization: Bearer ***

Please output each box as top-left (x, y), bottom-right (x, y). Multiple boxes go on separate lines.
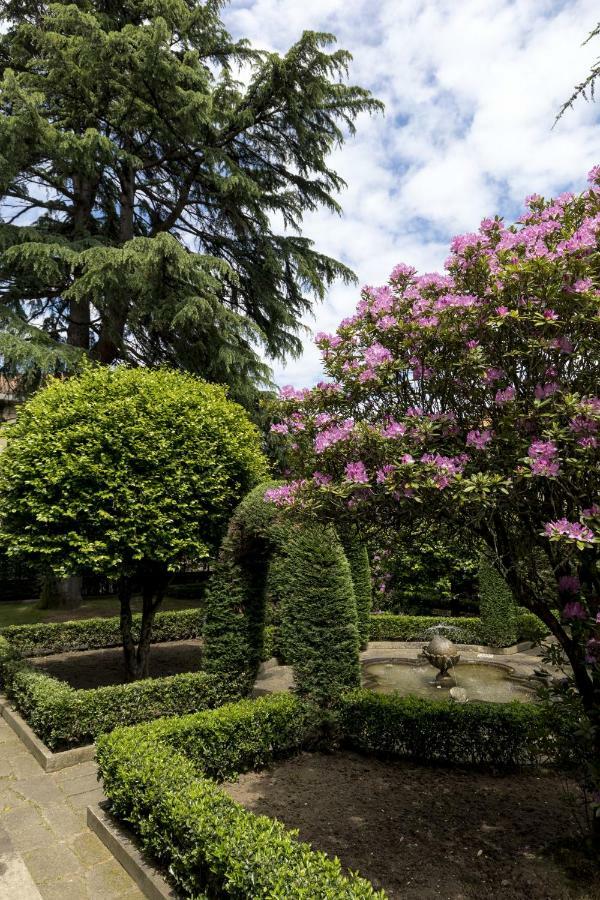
top-left (224, 753), bottom-right (600, 900)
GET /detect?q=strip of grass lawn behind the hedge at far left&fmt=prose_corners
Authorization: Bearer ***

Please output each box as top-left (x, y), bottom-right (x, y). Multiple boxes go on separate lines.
top-left (0, 597), bottom-right (200, 628)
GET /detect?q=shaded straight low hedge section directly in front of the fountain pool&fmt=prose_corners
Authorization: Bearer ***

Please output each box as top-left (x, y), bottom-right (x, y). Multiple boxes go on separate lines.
top-left (337, 690), bottom-right (572, 769)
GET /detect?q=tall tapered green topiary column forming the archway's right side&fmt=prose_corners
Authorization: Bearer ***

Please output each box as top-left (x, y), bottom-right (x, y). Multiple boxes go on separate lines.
top-left (280, 525), bottom-right (360, 704)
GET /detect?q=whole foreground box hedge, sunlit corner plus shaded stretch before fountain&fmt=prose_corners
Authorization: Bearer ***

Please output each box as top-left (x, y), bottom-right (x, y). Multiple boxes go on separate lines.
top-left (97, 690), bottom-right (559, 900)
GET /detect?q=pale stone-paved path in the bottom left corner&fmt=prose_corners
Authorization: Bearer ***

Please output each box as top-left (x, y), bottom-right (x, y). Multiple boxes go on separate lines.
top-left (0, 719), bottom-right (144, 900)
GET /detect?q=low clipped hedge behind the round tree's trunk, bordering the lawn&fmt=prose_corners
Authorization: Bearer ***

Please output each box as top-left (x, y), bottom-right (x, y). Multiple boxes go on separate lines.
top-left (2, 609), bottom-right (204, 656)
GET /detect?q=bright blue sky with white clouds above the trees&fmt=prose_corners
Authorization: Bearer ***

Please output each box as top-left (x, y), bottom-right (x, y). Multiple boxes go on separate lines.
top-left (224, 0), bottom-right (600, 387)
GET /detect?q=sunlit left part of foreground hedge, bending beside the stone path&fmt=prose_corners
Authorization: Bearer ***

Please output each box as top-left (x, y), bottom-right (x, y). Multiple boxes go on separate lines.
top-left (98, 695), bottom-right (385, 900)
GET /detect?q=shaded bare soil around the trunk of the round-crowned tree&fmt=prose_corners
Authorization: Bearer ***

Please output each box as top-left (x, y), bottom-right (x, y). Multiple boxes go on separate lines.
top-left (30, 640), bottom-right (202, 688)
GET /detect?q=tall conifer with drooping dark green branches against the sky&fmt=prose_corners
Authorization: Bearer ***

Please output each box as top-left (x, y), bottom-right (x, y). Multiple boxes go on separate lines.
top-left (0, 0), bottom-right (380, 399)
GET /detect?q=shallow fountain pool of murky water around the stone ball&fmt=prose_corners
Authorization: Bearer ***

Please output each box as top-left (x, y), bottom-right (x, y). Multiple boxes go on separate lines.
top-left (362, 657), bottom-right (537, 703)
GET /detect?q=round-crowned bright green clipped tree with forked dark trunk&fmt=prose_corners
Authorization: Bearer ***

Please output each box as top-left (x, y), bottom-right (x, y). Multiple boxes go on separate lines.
top-left (0, 367), bottom-right (265, 679)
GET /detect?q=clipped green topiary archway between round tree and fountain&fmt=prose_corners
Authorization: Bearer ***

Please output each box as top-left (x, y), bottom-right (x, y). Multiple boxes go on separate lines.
top-left (204, 482), bottom-right (366, 693)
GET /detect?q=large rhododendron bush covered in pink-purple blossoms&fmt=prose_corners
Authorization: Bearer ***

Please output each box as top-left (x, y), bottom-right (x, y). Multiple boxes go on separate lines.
top-left (270, 167), bottom-right (600, 824)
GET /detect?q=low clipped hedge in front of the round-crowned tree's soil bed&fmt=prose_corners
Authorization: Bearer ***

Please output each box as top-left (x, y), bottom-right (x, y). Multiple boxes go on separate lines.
top-left (6, 666), bottom-right (241, 750)
